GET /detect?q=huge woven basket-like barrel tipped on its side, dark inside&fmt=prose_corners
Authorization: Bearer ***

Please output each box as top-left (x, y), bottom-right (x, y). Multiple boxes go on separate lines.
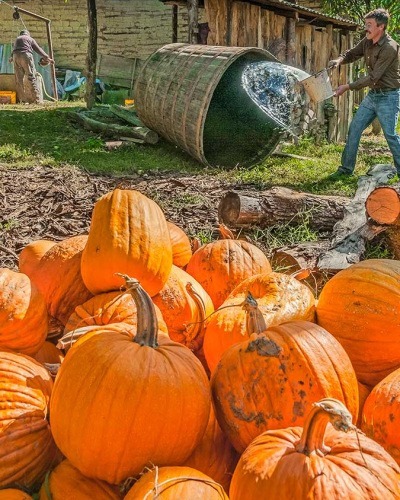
top-left (134, 43), bottom-right (284, 168)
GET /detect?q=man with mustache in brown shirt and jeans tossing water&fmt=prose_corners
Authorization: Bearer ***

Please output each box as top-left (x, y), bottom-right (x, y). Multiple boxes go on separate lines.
top-left (328, 9), bottom-right (400, 179)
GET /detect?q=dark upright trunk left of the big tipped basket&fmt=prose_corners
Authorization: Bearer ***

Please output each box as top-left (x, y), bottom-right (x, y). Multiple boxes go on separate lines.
top-left (85, 0), bottom-right (97, 109)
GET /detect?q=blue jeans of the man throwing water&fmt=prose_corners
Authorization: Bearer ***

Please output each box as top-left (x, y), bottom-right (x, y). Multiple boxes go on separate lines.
top-left (339, 89), bottom-right (400, 176)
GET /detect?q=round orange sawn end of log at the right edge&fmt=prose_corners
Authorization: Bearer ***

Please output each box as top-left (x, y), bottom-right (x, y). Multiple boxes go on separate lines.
top-left (365, 186), bottom-right (400, 225)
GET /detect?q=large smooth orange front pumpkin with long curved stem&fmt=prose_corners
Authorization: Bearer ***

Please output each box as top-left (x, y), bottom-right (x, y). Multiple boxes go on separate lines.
top-left (51, 277), bottom-right (210, 484)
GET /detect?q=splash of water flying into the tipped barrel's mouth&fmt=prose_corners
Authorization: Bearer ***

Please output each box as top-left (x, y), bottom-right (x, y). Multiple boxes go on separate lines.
top-left (242, 61), bottom-right (310, 137)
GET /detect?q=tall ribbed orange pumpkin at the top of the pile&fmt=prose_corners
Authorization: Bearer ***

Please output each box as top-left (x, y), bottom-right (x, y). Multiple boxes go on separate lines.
top-left (81, 189), bottom-right (172, 296)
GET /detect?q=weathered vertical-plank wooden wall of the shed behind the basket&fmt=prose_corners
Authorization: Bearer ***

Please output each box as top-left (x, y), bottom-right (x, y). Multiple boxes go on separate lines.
top-left (205, 0), bottom-right (353, 141)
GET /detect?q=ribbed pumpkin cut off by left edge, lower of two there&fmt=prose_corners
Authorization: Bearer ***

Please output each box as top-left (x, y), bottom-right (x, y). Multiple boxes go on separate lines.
top-left (0, 351), bottom-right (59, 490)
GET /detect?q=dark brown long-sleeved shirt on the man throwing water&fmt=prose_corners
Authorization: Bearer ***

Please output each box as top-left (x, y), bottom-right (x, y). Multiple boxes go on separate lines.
top-left (341, 34), bottom-right (400, 90)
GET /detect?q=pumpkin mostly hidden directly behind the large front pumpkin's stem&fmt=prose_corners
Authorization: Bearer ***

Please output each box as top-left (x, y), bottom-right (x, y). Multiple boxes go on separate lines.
top-left (64, 291), bottom-right (168, 334)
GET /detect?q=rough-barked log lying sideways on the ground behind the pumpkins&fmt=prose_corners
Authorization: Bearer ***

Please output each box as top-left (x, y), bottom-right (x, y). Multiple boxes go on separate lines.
top-left (218, 187), bottom-right (349, 231)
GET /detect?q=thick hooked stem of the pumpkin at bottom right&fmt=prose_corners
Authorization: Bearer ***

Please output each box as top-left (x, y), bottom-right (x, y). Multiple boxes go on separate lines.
top-left (296, 398), bottom-right (355, 456)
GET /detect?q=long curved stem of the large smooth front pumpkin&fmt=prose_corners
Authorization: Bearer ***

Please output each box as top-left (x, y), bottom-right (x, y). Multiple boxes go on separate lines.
top-left (116, 273), bottom-right (158, 347)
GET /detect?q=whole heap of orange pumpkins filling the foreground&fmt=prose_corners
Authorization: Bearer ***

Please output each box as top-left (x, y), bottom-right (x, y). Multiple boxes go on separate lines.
top-left (0, 189), bottom-right (400, 500)
